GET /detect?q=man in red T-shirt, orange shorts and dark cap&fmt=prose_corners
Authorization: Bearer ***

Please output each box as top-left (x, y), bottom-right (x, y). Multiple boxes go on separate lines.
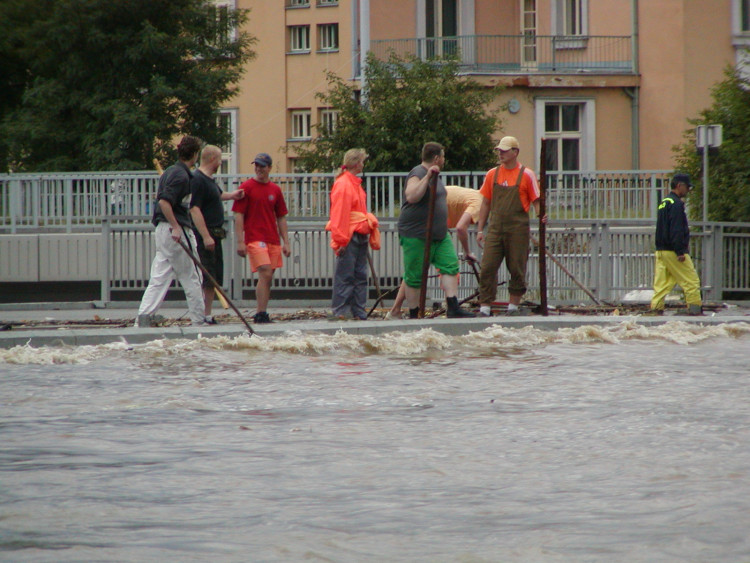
top-left (232, 153), bottom-right (291, 323)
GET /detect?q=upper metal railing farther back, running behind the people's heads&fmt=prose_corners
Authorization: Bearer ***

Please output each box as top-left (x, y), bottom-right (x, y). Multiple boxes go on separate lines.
top-left (0, 170), bottom-right (671, 233)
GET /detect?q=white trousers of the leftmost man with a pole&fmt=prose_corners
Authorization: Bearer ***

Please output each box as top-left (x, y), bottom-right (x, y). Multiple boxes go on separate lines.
top-left (138, 221), bottom-right (205, 324)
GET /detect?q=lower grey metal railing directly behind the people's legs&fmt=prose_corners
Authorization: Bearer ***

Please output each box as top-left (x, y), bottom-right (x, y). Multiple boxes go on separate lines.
top-left (95, 220), bottom-right (750, 303)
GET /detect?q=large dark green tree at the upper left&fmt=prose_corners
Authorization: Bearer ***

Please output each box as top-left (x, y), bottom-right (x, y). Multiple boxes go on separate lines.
top-left (0, 0), bottom-right (254, 171)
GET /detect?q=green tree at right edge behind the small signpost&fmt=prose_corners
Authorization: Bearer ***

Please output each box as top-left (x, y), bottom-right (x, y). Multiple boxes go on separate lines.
top-left (673, 68), bottom-right (750, 222)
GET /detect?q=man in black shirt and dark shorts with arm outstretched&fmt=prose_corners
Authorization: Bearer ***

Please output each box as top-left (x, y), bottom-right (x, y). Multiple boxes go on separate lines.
top-left (190, 145), bottom-right (245, 324)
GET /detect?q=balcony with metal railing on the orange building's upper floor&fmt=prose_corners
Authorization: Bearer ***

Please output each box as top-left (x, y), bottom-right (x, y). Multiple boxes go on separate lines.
top-left (370, 35), bottom-right (635, 74)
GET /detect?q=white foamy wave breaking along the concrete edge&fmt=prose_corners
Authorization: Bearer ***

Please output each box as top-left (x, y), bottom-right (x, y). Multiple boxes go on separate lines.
top-left (0, 320), bottom-right (750, 364)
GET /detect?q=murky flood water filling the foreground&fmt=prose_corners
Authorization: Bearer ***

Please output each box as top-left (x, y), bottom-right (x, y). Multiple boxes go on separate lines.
top-left (0, 323), bottom-right (750, 562)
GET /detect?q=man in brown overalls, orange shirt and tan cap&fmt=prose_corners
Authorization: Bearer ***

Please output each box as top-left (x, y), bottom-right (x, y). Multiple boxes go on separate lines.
top-left (477, 137), bottom-right (547, 317)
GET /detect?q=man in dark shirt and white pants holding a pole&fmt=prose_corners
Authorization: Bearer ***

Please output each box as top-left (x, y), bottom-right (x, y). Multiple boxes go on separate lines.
top-left (135, 136), bottom-right (207, 327)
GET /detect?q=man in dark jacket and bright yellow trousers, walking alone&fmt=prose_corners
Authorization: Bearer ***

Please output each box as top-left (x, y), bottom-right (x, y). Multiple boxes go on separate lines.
top-left (651, 173), bottom-right (703, 315)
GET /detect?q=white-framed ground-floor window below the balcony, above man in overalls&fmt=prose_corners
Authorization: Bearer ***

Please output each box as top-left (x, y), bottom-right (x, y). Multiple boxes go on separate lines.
top-left (536, 98), bottom-right (596, 172)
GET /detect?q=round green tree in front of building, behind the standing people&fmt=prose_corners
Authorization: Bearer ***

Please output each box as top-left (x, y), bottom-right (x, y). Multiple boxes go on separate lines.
top-left (297, 54), bottom-right (499, 172)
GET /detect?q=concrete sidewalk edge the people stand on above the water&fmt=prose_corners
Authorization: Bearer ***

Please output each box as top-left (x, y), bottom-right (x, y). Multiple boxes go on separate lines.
top-left (0, 301), bottom-right (750, 348)
